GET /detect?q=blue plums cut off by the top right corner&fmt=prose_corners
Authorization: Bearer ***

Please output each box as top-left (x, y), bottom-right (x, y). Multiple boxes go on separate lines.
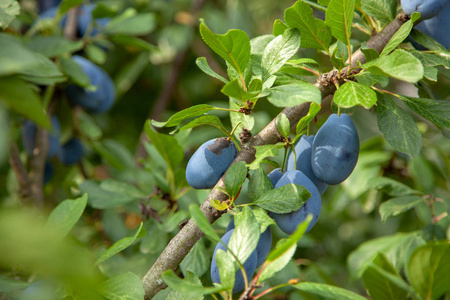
top-left (401, 0), bottom-right (450, 49)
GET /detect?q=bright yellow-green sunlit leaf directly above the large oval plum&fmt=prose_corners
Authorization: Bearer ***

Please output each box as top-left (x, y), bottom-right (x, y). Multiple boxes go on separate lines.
top-left (333, 81), bottom-right (377, 109)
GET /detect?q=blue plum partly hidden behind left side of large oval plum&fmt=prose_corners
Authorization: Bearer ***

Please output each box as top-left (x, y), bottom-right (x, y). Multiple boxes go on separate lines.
top-left (287, 135), bottom-right (328, 195)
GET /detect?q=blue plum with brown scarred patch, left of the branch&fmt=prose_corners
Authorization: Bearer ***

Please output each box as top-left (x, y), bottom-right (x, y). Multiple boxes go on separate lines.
top-left (186, 138), bottom-right (237, 189)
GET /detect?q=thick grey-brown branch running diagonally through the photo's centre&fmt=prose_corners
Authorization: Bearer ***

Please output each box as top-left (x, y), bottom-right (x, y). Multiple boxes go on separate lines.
top-left (142, 14), bottom-right (408, 299)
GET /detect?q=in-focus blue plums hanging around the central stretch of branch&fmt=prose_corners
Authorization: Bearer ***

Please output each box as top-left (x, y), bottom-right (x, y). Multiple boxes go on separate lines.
top-left (186, 114), bottom-right (359, 293)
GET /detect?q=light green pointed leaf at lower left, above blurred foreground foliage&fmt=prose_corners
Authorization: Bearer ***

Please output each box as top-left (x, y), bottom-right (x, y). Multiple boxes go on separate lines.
top-left (46, 194), bottom-right (87, 238)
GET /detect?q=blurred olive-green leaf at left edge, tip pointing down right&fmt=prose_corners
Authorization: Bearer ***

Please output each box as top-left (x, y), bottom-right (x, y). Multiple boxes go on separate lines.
top-left (0, 76), bottom-right (50, 128)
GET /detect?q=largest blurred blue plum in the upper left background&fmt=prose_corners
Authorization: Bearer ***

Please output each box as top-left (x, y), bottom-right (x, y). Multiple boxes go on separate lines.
top-left (67, 55), bottom-right (116, 114)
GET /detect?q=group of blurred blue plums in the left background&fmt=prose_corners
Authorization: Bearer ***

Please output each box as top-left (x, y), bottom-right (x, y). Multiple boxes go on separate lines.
top-left (22, 1), bottom-right (116, 184)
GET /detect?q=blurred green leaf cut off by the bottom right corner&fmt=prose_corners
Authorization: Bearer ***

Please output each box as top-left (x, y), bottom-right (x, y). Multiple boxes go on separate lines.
top-left (407, 241), bottom-right (450, 299)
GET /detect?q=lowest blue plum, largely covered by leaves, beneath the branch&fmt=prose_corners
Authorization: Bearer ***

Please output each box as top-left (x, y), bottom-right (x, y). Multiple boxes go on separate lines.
top-left (211, 229), bottom-right (257, 294)
